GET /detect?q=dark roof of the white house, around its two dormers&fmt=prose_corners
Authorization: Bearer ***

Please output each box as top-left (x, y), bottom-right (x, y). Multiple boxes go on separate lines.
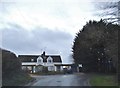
top-left (18, 55), bottom-right (62, 62)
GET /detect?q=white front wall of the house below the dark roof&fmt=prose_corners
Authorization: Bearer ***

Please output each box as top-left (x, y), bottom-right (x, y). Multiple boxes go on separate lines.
top-left (22, 58), bottom-right (63, 73)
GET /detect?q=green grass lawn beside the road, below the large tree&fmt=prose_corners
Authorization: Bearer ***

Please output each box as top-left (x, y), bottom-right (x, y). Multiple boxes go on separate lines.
top-left (90, 74), bottom-right (117, 86)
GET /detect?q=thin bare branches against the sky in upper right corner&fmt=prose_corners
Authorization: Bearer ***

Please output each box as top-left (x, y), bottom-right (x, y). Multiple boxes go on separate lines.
top-left (95, 0), bottom-right (120, 24)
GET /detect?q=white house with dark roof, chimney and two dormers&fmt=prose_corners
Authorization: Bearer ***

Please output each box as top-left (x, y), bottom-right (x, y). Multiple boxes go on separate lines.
top-left (18, 52), bottom-right (63, 73)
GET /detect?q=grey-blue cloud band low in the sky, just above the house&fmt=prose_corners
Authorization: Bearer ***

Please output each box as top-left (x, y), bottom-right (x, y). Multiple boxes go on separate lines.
top-left (1, 24), bottom-right (73, 63)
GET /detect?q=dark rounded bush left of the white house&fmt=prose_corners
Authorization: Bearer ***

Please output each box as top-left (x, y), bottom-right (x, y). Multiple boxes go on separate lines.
top-left (2, 49), bottom-right (21, 78)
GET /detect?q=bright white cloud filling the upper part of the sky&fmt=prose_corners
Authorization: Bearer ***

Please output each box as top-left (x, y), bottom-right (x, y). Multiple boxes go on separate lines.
top-left (0, 0), bottom-right (97, 35)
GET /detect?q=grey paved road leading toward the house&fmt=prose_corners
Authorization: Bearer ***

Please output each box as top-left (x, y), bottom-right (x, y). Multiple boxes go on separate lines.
top-left (27, 73), bottom-right (89, 86)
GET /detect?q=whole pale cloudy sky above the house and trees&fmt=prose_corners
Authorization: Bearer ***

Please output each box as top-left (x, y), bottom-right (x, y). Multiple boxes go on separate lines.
top-left (0, 0), bottom-right (116, 63)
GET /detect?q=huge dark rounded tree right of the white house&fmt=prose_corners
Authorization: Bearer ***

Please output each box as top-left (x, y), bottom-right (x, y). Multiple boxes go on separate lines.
top-left (72, 20), bottom-right (120, 72)
